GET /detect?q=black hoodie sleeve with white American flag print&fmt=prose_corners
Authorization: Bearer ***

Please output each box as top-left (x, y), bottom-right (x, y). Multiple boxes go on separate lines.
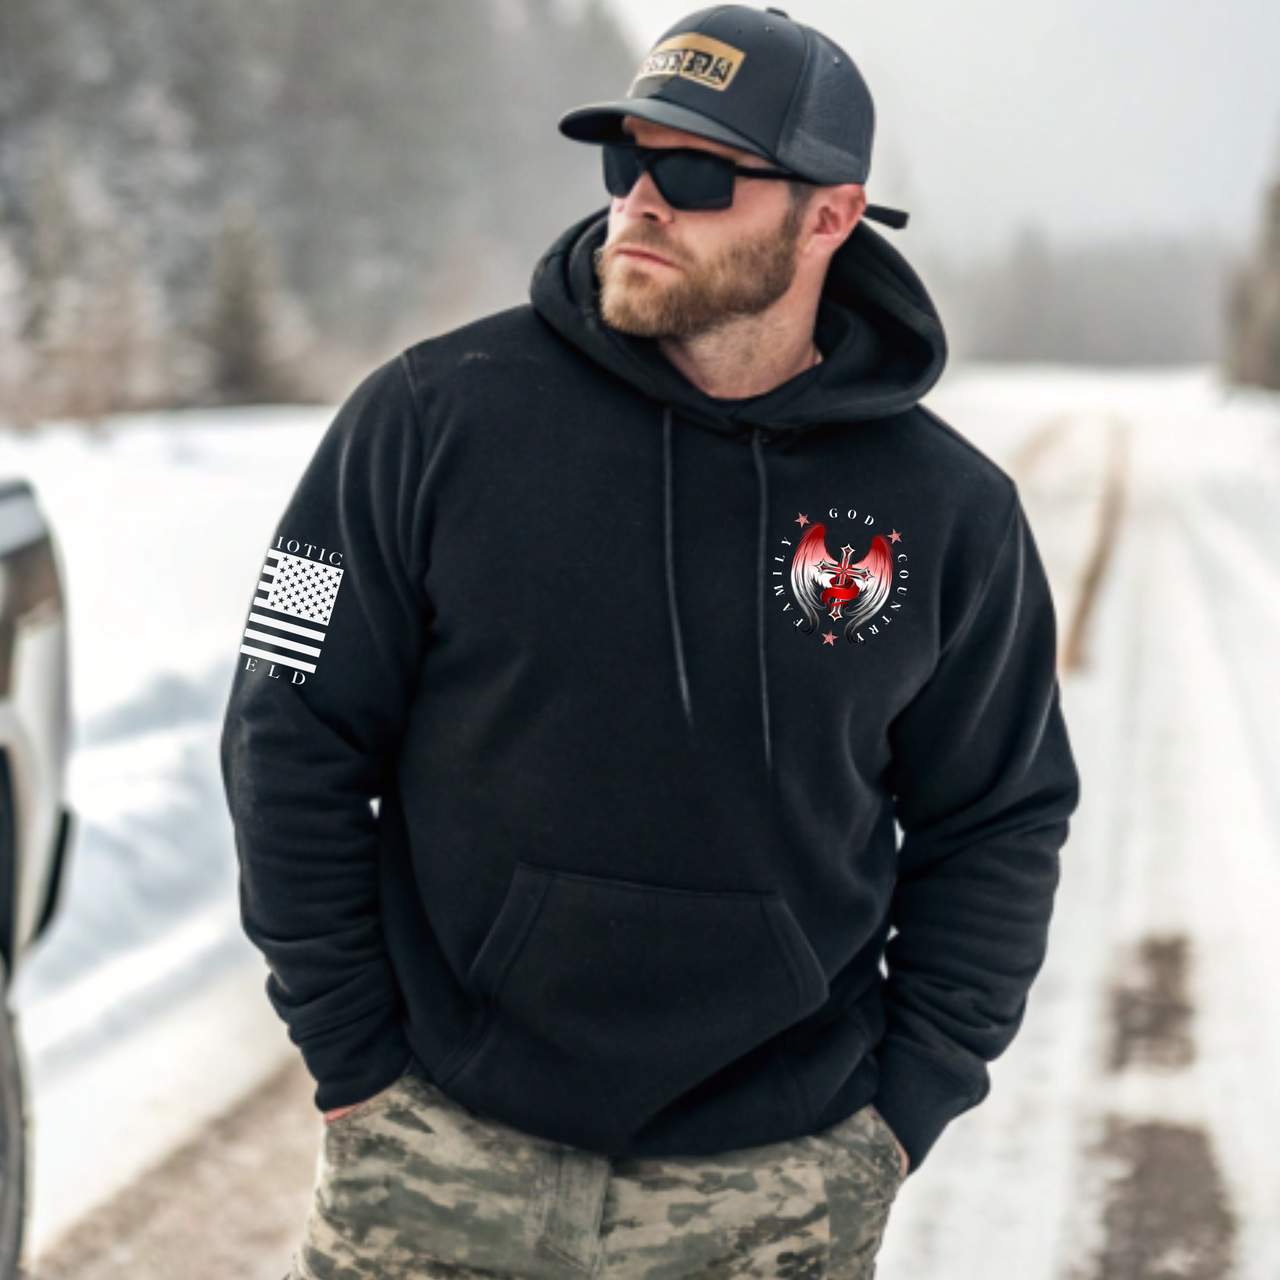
top-left (221, 357), bottom-right (430, 1111)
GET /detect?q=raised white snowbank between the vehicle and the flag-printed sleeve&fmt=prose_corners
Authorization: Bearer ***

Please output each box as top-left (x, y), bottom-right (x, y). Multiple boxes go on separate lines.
top-left (0, 408), bottom-right (333, 993)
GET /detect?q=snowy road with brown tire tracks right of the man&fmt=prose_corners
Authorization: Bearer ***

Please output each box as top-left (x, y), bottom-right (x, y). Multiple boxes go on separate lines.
top-left (877, 375), bottom-right (1280, 1280)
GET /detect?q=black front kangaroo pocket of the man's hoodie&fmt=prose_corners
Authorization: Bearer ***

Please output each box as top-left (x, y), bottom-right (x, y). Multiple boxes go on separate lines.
top-left (438, 863), bottom-right (827, 1149)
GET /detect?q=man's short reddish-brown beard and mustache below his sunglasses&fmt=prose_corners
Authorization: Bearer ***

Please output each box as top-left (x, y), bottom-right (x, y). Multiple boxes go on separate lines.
top-left (595, 204), bottom-right (804, 338)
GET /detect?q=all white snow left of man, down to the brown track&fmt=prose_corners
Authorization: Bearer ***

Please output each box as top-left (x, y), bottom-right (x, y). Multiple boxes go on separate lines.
top-left (0, 407), bottom-right (333, 1253)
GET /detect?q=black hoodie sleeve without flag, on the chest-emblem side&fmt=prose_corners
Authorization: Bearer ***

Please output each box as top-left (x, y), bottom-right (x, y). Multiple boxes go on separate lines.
top-left (874, 494), bottom-right (1079, 1170)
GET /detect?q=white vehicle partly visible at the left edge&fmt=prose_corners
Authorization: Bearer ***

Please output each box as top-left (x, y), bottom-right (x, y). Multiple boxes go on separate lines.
top-left (0, 480), bottom-right (70, 1280)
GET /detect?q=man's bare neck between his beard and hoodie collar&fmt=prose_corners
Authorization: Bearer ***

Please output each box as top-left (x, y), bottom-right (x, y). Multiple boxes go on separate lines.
top-left (658, 299), bottom-right (822, 399)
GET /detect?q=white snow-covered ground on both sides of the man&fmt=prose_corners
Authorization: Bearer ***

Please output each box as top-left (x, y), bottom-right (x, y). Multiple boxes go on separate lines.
top-left (0, 366), bottom-right (1280, 1280)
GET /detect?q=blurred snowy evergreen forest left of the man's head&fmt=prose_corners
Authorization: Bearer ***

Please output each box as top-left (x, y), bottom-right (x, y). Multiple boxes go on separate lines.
top-left (0, 0), bottom-right (639, 412)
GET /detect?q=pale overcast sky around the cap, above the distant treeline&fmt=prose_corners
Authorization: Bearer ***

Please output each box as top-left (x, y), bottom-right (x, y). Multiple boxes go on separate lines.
top-left (596, 0), bottom-right (1280, 256)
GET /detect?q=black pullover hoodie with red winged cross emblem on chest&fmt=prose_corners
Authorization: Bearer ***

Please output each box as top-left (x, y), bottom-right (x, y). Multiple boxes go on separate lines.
top-left (223, 214), bottom-right (1078, 1169)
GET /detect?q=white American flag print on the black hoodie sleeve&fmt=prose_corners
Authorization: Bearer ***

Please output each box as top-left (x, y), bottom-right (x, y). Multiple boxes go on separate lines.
top-left (241, 550), bottom-right (343, 671)
